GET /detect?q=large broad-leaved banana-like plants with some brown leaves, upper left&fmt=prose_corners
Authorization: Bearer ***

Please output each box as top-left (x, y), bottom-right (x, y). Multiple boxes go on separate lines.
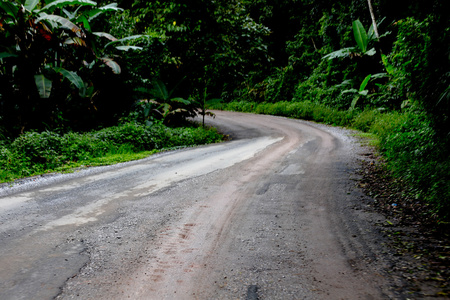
top-left (0, 0), bottom-right (140, 136)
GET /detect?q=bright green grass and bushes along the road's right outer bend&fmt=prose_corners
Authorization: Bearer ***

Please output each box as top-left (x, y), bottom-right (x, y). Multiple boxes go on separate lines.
top-left (219, 101), bottom-right (450, 223)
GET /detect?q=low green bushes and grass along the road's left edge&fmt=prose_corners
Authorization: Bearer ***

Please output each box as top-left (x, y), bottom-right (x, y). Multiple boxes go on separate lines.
top-left (0, 123), bottom-right (222, 182)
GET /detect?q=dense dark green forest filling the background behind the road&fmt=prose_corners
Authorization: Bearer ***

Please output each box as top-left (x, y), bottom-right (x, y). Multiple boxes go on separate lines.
top-left (0, 0), bottom-right (450, 221)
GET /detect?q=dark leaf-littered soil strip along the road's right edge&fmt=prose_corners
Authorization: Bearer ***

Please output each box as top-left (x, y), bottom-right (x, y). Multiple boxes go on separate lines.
top-left (358, 150), bottom-right (450, 299)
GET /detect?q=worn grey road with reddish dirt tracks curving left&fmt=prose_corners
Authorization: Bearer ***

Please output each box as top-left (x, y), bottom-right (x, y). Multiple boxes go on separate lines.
top-left (0, 112), bottom-right (389, 299)
